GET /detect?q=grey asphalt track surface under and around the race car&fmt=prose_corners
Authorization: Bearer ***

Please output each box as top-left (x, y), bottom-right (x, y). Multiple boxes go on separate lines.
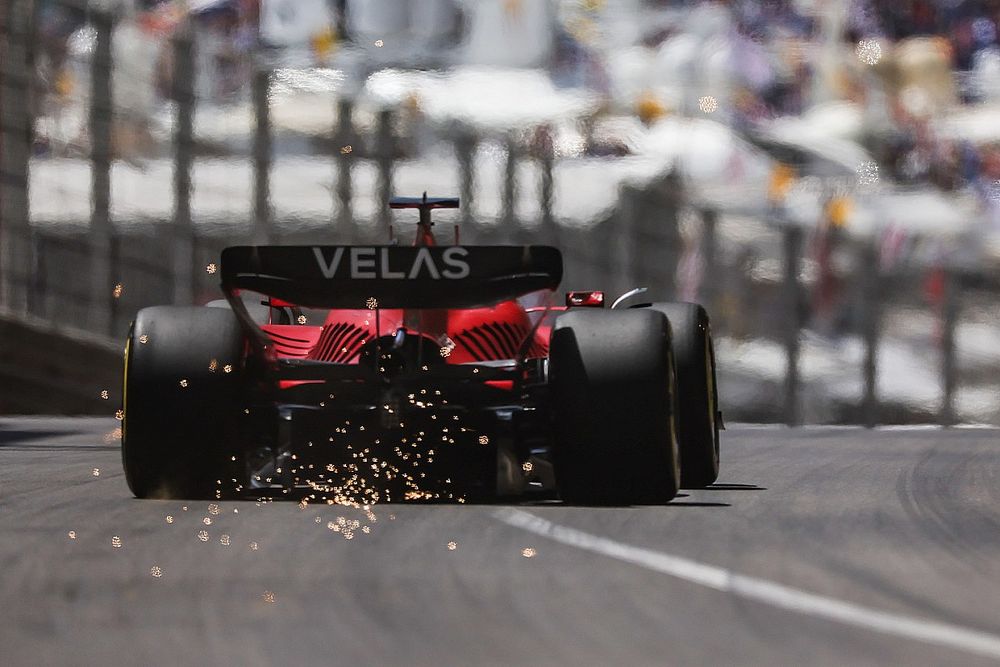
top-left (0, 418), bottom-right (1000, 665)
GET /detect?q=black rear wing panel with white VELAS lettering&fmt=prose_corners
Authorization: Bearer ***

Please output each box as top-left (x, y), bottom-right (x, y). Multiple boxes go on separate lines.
top-left (221, 246), bottom-right (563, 309)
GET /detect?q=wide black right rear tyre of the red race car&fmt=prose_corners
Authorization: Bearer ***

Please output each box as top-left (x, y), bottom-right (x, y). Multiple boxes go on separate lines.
top-left (549, 310), bottom-right (680, 505)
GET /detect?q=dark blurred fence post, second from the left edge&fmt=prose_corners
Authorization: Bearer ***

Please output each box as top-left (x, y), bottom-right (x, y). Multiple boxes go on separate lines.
top-left (89, 12), bottom-right (115, 340)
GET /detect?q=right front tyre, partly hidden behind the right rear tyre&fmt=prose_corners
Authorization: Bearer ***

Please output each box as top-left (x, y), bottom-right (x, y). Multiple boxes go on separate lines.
top-left (648, 303), bottom-right (719, 489)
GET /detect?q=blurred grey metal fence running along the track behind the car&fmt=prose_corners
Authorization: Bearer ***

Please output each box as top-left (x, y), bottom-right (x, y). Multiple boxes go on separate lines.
top-left (0, 0), bottom-right (1000, 426)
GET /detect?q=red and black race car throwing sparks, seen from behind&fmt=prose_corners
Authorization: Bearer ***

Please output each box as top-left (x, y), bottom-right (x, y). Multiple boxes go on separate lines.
top-left (122, 193), bottom-right (721, 505)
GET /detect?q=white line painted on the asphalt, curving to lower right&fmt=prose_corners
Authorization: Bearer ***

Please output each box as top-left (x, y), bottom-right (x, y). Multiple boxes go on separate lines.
top-left (494, 508), bottom-right (1000, 659)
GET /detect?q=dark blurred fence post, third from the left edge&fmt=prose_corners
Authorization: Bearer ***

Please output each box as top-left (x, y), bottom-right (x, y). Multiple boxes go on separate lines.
top-left (172, 21), bottom-right (196, 304)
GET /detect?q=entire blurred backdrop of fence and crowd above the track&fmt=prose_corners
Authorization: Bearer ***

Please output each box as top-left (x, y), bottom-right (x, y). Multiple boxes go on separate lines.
top-left (0, 0), bottom-right (1000, 425)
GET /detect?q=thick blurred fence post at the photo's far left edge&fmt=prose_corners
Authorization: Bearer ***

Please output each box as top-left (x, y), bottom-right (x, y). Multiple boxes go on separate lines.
top-left (0, 0), bottom-right (35, 312)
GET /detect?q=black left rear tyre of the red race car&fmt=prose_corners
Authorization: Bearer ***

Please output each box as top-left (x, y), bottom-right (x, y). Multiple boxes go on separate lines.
top-left (122, 306), bottom-right (244, 498)
